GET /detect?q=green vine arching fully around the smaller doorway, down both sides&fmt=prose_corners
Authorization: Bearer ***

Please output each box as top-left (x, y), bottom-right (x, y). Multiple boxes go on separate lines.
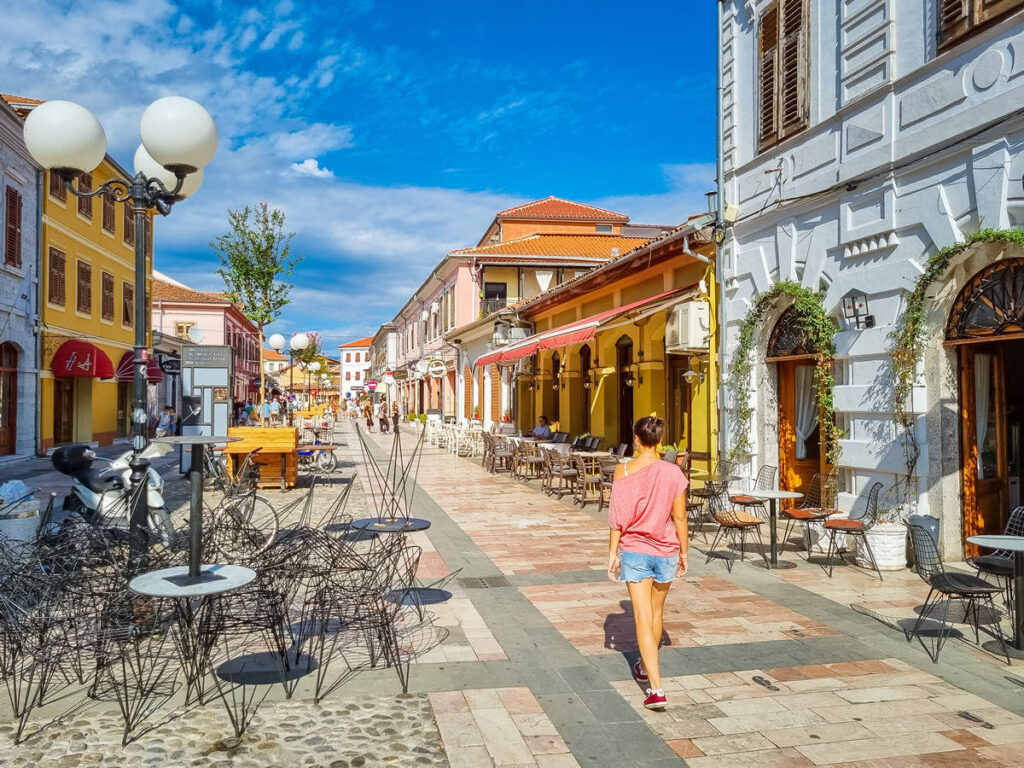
top-left (726, 281), bottom-right (843, 466)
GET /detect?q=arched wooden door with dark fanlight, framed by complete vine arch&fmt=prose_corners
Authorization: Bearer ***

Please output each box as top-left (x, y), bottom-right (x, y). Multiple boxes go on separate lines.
top-left (765, 307), bottom-right (825, 490)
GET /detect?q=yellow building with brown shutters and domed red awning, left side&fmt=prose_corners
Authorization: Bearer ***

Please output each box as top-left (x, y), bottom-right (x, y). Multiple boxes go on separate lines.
top-left (40, 161), bottom-right (153, 451)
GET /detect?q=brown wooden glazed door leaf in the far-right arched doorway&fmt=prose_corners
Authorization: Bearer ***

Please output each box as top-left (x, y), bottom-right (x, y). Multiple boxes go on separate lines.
top-left (959, 344), bottom-right (1009, 556)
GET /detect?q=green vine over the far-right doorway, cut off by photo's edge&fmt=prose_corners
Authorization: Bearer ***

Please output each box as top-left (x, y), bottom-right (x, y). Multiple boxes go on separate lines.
top-left (889, 229), bottom-right (1024, 487)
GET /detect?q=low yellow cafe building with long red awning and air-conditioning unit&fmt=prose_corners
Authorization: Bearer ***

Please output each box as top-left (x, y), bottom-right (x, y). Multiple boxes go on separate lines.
top-left (478, 221), bottom-right (719, 469)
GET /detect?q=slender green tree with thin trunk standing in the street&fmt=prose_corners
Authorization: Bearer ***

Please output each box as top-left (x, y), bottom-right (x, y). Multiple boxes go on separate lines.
top-left (210, 203), bottom-right (302, 423)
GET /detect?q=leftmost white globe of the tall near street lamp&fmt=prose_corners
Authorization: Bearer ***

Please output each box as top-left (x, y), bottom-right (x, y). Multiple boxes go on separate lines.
top-left (25, 101), bottom-right (106, 175)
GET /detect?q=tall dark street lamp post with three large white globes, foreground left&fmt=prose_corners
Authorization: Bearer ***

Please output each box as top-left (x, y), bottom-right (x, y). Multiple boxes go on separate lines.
top-left (25, 96), bottom-right (217, 561)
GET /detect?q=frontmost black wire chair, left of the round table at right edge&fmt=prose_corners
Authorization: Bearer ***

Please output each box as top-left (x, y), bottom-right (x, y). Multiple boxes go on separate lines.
top-left (906, 522), bottom-right (1010, 665)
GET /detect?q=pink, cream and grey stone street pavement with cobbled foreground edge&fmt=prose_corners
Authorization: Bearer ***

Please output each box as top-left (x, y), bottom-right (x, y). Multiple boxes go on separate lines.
top-left (6, 423), bottom-right (1024, 768)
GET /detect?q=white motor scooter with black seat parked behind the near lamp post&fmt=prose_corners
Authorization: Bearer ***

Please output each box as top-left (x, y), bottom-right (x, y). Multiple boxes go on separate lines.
top-left (51, 442), bottom-right (174, 545)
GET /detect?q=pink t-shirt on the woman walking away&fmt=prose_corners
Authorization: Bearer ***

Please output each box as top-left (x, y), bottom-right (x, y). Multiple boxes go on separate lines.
top-left (608, 461), bottom-right (689, 557)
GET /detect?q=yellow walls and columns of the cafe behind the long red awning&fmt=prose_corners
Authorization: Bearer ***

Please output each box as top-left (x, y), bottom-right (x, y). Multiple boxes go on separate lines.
top-left (519, 249), bottom-right (718, 468)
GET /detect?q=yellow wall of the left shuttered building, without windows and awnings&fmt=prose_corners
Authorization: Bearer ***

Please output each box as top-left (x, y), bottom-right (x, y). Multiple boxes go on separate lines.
top-left (40, 158), bottom-right (154, 450)
